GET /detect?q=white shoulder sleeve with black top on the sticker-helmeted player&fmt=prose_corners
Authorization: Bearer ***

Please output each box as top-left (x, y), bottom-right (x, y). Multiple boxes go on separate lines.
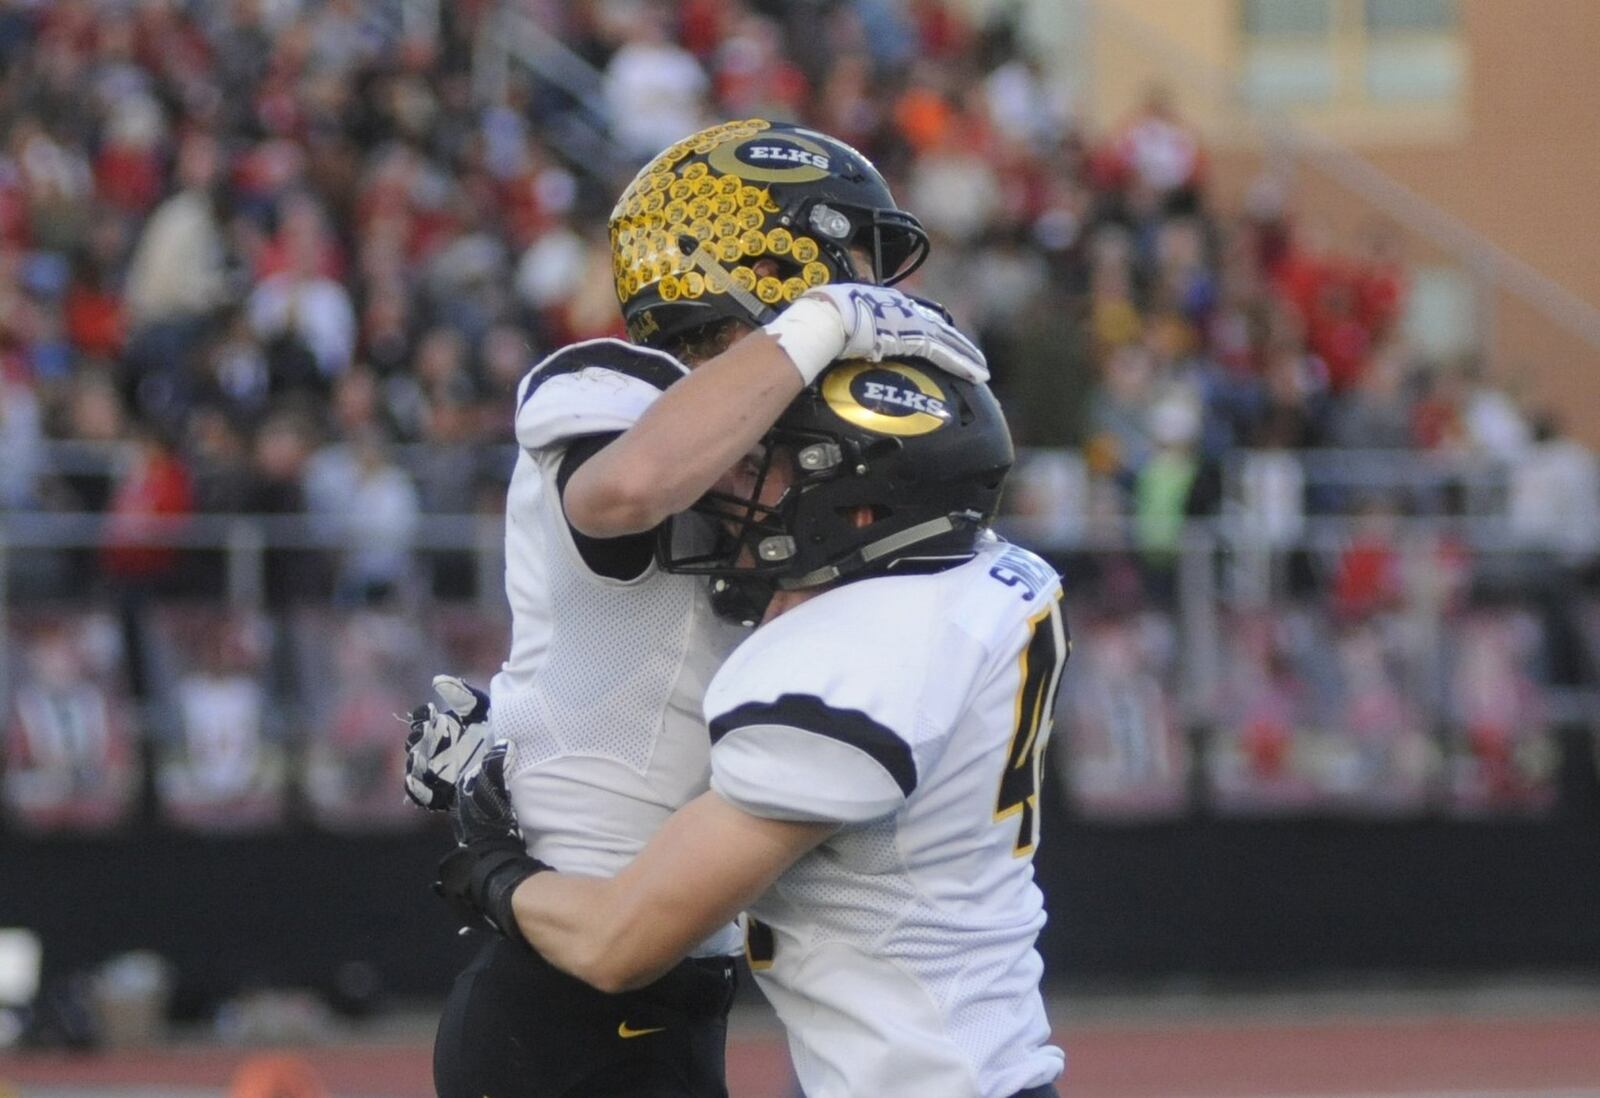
top-left (517, 339), bottom-right (688, 450)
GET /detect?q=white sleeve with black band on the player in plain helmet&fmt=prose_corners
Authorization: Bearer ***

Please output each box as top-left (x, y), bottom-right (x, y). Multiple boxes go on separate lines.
top-left (707, 693), bottom-right (917, 824)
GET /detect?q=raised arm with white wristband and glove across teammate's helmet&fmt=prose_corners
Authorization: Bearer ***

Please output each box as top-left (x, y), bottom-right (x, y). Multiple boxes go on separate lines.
top-left (562, 283), bottom-right (989, 538)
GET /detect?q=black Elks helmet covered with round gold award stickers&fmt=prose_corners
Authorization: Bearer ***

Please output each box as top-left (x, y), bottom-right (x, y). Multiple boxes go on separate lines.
top-left (610, 118), bottom-right (928, 347)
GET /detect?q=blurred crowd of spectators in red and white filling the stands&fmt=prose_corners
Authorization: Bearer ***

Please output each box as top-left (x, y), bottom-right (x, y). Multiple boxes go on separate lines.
top-left (0, 0), bottom-right (1600, 826)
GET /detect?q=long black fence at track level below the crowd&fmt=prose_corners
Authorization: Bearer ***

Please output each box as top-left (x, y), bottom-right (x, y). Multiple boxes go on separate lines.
top-left (0, 730), bottom-right (1600, 1013)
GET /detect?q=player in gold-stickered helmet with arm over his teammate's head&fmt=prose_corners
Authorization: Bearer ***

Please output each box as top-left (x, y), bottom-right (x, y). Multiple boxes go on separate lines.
top-left (406, 113), bottom-right (987, 1098)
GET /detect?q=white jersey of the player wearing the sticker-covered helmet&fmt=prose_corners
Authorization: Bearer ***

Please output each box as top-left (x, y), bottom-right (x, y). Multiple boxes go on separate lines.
top-left (490, 339), bottom-right (744, 954)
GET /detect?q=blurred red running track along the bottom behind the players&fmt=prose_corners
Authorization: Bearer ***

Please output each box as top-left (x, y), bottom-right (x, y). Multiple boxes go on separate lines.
top-left (0, 1015), bottom-right (1600, 1098)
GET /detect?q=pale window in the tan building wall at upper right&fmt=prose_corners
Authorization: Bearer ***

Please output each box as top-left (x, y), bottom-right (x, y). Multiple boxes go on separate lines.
top-left (1238, 0), bottom-right (1466, 107)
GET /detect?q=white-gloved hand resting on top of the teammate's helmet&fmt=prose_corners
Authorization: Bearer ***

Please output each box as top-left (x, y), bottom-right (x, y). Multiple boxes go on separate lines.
top-left (800, 283), bottom-right (989, 384)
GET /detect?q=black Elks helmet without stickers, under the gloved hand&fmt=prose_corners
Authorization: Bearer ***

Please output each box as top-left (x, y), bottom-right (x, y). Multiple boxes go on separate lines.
top-left (659, 360), bottom-right (1014, 623)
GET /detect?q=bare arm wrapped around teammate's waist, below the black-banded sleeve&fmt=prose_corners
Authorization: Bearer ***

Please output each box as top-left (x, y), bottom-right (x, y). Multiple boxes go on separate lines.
top-left (512, 792), bottom-right (837, 992)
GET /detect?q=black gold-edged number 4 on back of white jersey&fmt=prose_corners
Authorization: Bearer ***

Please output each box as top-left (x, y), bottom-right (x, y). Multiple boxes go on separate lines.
top-left (995, 594), bottom-right (1072, 858)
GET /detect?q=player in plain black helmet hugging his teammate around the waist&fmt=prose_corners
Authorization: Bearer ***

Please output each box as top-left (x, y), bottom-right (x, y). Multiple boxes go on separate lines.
top-left (440, 360), bottom-right (1069, 1098)
